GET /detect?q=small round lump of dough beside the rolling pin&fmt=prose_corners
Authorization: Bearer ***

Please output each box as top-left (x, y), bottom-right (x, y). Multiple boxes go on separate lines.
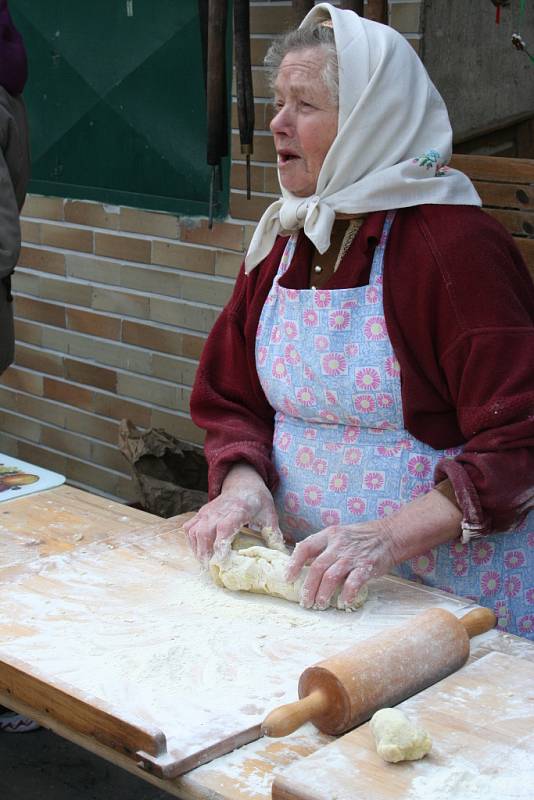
top-left (370, 708), bottom-right (432, 763)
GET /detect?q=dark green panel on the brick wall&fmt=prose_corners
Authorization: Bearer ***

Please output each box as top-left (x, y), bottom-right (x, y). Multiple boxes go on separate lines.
top-left (10, 0), bottom-right (229, 216)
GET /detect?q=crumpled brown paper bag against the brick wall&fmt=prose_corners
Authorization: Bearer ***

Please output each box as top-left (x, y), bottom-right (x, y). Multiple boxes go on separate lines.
top-left (119, 419), bottom-right (208, 518)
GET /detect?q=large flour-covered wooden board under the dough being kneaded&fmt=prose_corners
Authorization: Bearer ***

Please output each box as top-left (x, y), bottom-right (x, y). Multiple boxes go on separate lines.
top-left (0, 520), bottom-right (478, 777)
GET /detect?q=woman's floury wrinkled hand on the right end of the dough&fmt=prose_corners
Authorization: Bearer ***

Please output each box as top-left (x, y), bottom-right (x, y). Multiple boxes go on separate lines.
top-left (287, 520), bottom-right (396, 609)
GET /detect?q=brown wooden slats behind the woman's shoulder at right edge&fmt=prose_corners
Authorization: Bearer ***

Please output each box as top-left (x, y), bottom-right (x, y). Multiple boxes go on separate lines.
top-left (451, 155), bottom-right (534, 279)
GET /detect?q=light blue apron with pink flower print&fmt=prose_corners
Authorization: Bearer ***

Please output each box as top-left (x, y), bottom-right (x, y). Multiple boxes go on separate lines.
top-left (256, 212), bottom-right (534, 638)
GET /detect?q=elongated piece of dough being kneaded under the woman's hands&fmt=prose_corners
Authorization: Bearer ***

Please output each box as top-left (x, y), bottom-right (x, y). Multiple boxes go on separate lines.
top-left (210, 546), bottom-right (367, 611)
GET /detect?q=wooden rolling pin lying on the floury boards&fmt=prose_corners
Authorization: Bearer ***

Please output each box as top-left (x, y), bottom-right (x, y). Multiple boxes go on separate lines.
top-left (262, 608), bottom-right (497, 736)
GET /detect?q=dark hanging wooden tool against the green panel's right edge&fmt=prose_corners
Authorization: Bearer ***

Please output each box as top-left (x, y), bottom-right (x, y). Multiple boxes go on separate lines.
top-left (206, 0), bottom-right (228, 228)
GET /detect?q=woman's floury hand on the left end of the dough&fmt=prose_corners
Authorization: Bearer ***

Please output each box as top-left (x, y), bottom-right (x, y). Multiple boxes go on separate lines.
top-left (183, 462), bottom-right (285, 565)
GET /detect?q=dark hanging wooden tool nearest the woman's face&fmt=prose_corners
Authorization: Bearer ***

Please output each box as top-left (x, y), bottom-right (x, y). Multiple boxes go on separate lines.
top-left (234, 0), bottom-right (254, 200)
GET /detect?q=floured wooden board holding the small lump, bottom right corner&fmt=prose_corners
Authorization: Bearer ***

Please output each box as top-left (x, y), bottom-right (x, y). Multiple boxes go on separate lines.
top-left (272, 653), bottom-right (534, 800)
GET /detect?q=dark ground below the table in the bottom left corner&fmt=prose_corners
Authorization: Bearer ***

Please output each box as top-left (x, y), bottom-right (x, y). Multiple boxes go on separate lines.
top-left (0, 728), bottom-right (171, 800)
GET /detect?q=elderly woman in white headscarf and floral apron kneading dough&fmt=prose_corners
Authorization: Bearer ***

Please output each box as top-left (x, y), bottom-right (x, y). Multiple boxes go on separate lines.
top-left (187, 3), bottom-right (534, 637)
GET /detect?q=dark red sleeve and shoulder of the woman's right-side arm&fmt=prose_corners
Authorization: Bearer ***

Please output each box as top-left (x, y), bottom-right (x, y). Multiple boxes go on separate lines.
top-left (384, 206), bottom-right (534, 536)
